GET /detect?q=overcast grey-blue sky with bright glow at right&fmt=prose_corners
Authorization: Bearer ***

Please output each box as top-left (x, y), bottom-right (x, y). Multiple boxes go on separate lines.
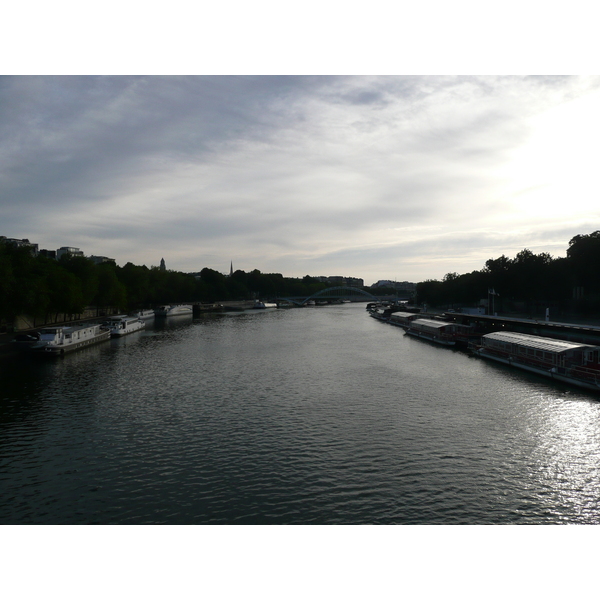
top-left (0, 76), bottom-right (600, 284)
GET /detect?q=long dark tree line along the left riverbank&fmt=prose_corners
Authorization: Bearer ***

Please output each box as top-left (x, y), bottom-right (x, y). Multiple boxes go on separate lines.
top-left (0, 244), bottom-right (328, 322)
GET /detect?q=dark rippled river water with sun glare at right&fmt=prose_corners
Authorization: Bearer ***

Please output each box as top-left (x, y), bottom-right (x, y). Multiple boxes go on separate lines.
top-left (0, 304), bottom-right (600, 524)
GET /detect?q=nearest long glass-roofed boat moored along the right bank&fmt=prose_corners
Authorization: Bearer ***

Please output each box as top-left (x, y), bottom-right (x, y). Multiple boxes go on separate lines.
top-left (471, 331), bottom-right (600, 392)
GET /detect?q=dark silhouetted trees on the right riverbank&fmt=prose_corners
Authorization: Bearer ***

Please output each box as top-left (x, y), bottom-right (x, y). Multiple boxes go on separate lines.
top-left (416, 231), bottom-right (600, 315)
